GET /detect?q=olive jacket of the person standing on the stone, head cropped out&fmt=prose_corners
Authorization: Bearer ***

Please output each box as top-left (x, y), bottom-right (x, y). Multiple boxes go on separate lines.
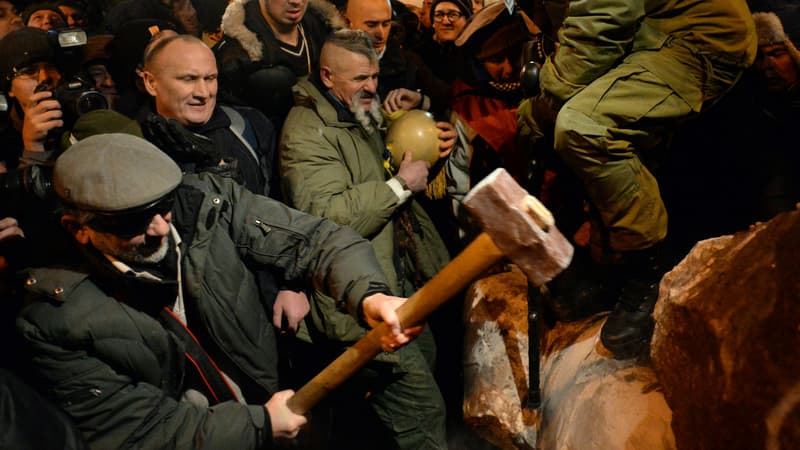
top-left (541, 0), bottom-right (756, 110)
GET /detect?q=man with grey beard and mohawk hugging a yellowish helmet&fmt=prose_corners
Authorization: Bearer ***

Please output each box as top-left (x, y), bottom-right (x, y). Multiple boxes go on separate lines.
top-left (280, 30), bottom-right (456, 450)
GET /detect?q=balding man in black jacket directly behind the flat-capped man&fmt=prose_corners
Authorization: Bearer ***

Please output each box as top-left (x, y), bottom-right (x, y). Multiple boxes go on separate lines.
top-left (142, 35), bottom-right (309, 331)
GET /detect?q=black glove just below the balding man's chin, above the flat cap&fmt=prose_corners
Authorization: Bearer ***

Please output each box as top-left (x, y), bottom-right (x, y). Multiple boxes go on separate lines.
top-left (142, 114), bottom-right (222, 168)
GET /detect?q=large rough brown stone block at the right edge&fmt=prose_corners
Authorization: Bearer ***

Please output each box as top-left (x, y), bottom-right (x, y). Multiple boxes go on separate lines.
top-left (651, 211), bottom-right (800, 450)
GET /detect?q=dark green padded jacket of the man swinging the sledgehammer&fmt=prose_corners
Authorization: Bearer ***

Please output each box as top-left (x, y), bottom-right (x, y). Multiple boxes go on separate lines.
top-left (17, 174), bottom-right (389, 449)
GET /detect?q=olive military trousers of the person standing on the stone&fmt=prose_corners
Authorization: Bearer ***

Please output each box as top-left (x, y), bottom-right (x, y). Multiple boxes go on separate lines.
top-left (555, 47), bottom-right (742, 251)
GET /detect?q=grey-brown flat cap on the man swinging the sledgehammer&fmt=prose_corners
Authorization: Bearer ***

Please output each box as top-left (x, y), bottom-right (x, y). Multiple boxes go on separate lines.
top-left (53, 133), bottom-right (181, 213)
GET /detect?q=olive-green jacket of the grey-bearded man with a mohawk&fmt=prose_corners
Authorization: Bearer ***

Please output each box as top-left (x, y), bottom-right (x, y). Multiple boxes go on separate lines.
top-left (279, 80), bottom-right (449, 341)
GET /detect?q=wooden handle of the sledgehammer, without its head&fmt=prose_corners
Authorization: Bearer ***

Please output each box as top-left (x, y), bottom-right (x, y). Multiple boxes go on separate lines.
top-left (288, 233), bottom-right (503, 414)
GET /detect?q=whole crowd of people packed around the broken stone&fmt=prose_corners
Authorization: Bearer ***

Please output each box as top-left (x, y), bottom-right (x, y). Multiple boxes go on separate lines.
top-left (0, 0), bottom-right (800, 450)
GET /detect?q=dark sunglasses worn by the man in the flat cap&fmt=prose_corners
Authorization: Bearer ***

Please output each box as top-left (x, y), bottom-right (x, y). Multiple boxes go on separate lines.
top-left (86, 191), bottom-right (175, 238)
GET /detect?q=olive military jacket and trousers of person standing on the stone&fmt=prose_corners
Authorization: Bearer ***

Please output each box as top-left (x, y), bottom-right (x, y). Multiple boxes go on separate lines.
top-left (520, 0), bottom-right (756, 251)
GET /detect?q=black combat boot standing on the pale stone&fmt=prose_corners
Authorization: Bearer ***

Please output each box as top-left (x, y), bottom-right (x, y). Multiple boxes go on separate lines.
top-left (600, 245), bottom-right (672, 359)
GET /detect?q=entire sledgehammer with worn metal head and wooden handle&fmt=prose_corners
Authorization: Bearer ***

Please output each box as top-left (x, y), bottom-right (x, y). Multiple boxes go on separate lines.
top-left (288, 169), bottom-right (573, 414)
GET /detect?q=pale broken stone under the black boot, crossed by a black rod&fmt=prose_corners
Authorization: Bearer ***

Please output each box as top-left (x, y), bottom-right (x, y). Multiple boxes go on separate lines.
top-left (464, 272), bottom-right (675, 450)
